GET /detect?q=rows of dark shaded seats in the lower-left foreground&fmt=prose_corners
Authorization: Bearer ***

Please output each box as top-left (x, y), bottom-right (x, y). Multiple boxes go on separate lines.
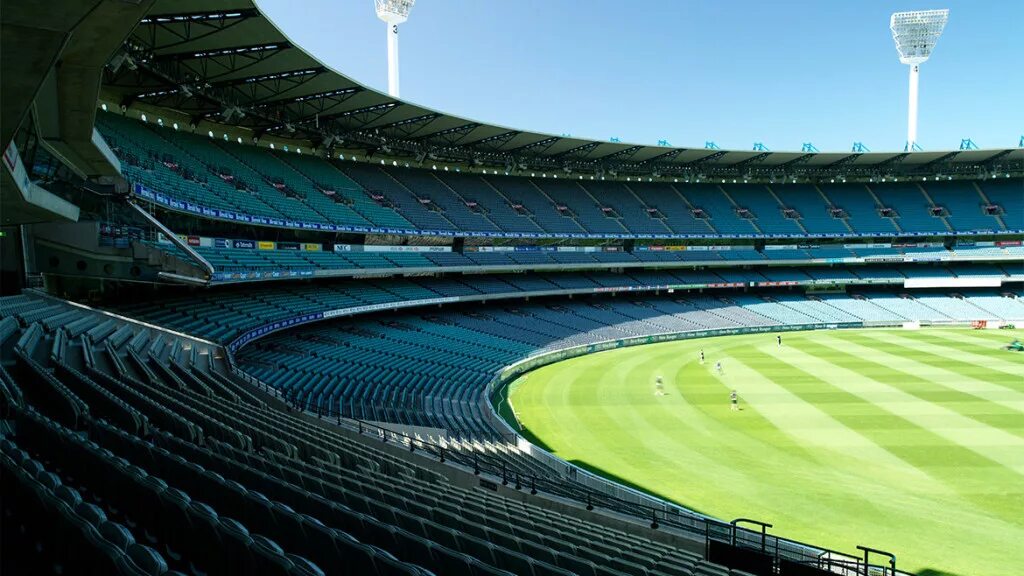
top-left (0, 297), bottom-right (761, 576)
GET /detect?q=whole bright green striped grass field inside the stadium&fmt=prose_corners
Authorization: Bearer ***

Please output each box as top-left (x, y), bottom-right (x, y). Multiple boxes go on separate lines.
top-left (509, 328), bottom-right (1024, 576)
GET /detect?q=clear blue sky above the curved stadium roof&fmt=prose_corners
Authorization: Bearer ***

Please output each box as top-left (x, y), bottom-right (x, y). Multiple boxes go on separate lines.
top-left (257, 0), bottom-right (1024, 152)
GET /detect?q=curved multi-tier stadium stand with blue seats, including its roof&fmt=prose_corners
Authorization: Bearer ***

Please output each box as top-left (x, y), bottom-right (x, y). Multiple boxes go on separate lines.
top-left (0, 0), bottom-right (1024, 576)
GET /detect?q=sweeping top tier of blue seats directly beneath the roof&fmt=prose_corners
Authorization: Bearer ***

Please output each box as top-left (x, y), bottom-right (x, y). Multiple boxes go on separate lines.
top-left (97, 113), bottom-right (1024, 237)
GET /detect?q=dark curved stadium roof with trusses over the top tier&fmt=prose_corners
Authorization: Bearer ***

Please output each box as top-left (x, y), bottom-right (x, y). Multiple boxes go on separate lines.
top-left (101, 0), bottom-right (1024, 178)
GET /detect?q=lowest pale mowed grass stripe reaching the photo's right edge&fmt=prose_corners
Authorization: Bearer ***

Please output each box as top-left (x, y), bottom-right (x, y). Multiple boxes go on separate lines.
top-left (762, 336), bottom-right (1024, 476)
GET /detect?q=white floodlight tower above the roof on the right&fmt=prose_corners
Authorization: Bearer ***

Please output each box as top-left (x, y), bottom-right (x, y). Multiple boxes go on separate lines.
top-left (889, 9), bottom-right (949, 152)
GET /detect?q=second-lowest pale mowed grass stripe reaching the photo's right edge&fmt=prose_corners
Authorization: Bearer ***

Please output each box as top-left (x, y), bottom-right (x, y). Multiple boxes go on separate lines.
top-left (815, 333), bottom-right (1024, 414)
